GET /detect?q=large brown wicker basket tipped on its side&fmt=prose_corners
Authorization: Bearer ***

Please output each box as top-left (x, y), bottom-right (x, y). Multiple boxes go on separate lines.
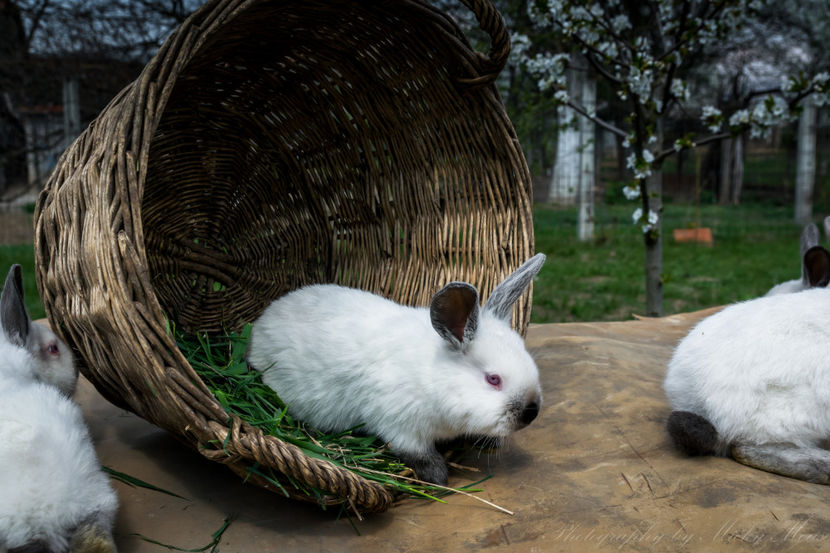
top-left (35, 0), bottom-right (533, 511)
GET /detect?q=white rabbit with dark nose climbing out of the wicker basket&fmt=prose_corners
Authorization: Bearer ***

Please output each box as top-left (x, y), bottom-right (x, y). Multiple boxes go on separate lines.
top-left (247, 254), bottom-right (545, 484)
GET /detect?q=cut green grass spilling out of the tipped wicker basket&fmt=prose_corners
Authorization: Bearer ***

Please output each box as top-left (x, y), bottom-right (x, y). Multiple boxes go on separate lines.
top-left (173, 324), bottom-right (479, 504)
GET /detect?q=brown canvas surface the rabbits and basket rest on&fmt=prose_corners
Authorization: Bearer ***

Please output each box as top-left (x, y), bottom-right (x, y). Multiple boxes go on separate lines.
top-left (77, 310), bottom-right (830, 553)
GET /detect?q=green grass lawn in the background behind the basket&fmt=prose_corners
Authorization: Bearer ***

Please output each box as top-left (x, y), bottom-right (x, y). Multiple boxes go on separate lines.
top-left (0, 202), bottom-right (816, 323)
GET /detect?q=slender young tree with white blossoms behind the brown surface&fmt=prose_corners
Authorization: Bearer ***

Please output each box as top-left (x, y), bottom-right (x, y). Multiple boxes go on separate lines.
top-left (513, 0), bottom-right (830, 316)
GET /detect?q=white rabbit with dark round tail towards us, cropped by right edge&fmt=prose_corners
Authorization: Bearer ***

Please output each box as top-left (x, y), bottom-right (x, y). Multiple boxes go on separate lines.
top-left (664, 288), bottom-right (830, 484)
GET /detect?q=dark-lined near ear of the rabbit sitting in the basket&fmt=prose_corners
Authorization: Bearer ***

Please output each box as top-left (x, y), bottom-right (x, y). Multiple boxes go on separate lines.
top-left (429, 282), bottom-right (479, 351)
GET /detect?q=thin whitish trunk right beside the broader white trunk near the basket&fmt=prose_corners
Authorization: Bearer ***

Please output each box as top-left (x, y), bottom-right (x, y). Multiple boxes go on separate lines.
top-left (577, 64), bottom-right (597, 242)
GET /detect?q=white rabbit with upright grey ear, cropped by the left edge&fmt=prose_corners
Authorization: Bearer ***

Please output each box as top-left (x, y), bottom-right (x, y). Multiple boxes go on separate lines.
top-left (0, 265), bottom-right (117, 553)
